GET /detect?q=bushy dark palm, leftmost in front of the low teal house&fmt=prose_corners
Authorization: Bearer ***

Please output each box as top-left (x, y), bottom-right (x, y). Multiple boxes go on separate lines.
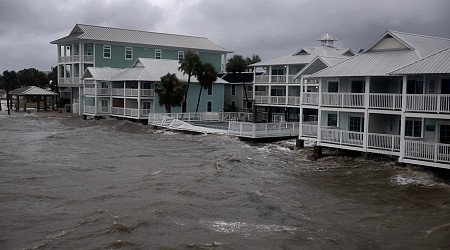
top-left (155, 73), bottom-right (184, 113)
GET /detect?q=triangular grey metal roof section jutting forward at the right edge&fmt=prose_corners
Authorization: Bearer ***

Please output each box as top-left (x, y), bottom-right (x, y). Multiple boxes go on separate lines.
top-left (392, 47), bottom-right (450, 75)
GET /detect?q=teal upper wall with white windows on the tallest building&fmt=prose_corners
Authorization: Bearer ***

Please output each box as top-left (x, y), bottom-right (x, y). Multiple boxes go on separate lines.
top-left (95, 43), bottom-right (222, 72)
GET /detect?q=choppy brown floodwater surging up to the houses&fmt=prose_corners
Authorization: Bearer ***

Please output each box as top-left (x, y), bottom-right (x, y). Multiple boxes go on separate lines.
top-left (0, 111), bottom-right (450, 249)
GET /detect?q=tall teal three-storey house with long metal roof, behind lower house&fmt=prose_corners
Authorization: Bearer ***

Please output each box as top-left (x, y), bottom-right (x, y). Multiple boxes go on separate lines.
top-left (51, 24), bottom-right (232, 115)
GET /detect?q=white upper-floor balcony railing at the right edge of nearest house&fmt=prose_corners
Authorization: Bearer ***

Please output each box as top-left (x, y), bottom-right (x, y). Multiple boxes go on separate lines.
top-left (406, 94), bottom-right (450, 113)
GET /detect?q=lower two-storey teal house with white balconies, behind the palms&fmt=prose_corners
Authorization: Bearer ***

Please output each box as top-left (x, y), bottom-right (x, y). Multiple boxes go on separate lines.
top-left (82, 58), bottom-right (227, 121)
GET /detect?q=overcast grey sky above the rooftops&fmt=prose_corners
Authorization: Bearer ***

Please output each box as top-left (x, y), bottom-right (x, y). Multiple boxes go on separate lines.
top-left (0, 0), bottom-right (450, 74)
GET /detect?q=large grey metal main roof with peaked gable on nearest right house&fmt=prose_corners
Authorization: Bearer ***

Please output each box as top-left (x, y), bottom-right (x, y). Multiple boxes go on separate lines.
top-left (311, 31), bottom-right (450, 78)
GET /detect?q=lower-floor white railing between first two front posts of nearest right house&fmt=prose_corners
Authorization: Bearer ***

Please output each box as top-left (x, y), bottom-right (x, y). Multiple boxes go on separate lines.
top-left (320, 128), bottom-right (364, 147)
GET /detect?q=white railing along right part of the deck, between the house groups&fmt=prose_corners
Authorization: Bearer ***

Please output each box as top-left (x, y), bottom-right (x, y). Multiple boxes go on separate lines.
top-left (228, 121), bottom-right (299, 138)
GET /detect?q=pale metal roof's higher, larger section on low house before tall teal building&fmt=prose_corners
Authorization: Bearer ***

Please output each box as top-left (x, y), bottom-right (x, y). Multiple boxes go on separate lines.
top-left (111, 58), bottom-right (227, 83)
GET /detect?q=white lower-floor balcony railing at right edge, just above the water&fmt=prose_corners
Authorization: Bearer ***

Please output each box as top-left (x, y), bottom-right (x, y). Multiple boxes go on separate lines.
top-left (405, 140), bottom-right (450, 163)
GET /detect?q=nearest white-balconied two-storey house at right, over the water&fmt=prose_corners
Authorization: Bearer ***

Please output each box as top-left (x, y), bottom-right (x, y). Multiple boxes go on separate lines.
top-left (300, 31), bottom-right (450, 168)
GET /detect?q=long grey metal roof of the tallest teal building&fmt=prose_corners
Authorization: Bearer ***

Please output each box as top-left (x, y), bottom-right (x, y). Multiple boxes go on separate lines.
top-left (51, 24), bottom-right (232, 53)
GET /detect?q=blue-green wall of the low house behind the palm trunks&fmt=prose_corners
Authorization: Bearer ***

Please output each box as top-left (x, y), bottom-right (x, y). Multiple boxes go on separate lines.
top-left (155, 82), bottom-right (225, 113)
